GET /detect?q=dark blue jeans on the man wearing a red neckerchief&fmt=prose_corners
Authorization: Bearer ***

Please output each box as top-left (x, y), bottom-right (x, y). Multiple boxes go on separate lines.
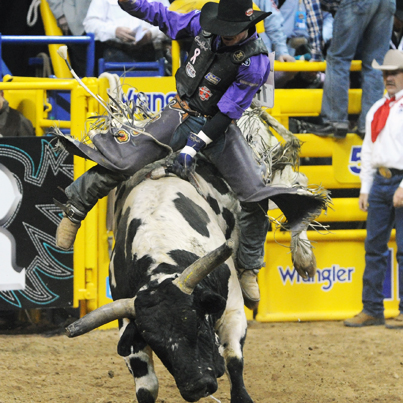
top-left (362, 174), bottom-right (403, 318)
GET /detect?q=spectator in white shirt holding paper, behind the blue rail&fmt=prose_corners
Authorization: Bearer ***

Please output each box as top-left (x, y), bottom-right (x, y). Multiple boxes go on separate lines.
top-left (84, 0), bottom-right (169, 63)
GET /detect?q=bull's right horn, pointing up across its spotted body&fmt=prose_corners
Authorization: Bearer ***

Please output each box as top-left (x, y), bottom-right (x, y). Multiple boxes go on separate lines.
top-left (173, 239), bottom-right (234, 295)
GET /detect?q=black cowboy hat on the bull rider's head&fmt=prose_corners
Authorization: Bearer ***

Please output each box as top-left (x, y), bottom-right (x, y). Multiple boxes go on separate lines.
top-left (200, 0), bottom-right (271, 36)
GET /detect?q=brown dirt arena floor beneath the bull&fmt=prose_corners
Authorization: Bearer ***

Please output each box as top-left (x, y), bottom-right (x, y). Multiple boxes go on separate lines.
top-left (0, 321), bottom-right (403, 403)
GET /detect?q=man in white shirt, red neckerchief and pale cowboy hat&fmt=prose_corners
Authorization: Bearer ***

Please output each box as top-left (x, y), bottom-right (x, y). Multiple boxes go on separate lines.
top-left (344, 50), bottom-right (403, 329)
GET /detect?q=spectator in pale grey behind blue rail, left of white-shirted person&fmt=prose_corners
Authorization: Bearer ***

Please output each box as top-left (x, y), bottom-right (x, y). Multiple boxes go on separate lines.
top-left (48, 0), bottom-right (91, 77)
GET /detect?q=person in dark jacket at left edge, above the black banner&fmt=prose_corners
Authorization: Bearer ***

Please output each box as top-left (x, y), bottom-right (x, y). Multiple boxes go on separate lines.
top-left (0, 90), bottom-right (35, 137)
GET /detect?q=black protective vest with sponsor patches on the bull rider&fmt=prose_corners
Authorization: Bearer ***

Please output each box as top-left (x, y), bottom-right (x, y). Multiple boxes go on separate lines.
top-left (175, 31), bottom-right (268, 116)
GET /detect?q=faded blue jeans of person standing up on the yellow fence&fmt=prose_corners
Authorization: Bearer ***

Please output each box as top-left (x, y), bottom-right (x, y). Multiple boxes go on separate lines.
top-left (321, 0), bottom-right (396, 132)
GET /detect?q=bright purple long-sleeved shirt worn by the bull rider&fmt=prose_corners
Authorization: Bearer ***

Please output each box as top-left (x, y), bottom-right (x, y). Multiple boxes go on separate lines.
top-left (119, 0), bottom-right (270, 119)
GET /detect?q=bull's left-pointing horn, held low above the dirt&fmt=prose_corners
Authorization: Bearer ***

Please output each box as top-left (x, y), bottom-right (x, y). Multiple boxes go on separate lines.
top-left (66, 298), bottom-right (135, 337)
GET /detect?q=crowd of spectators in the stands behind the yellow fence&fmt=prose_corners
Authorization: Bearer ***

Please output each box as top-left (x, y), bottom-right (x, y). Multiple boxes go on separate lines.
top-left (0, 0), bottom-right (403, 142)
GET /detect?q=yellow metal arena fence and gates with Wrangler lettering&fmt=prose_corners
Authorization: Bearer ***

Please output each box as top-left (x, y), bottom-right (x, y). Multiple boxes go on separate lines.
top-left (0, 63), bottom-right (398, 326)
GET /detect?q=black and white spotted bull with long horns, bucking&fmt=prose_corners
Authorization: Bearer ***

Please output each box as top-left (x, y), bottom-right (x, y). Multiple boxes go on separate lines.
top-left (67, 160), bottom-right (252, 403)
